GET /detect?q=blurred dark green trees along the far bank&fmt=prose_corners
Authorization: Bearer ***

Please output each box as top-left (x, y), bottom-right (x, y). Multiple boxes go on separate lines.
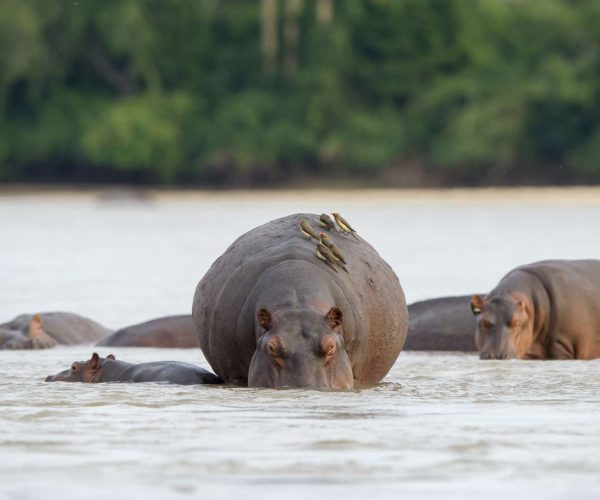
top-left (0, 0), bottom-right (600, 185)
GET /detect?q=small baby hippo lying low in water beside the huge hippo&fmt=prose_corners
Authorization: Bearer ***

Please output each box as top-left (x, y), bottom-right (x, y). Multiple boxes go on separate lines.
top-left (46, 353), bottom-right (223, 385)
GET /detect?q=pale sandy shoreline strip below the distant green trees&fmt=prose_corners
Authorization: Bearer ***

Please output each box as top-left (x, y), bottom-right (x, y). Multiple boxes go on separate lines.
top-left (0, 184), bottom-right (600, 205)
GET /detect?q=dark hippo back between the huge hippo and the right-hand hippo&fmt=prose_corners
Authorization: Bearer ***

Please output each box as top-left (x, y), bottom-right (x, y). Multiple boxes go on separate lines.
top-left (404, 295), bottom-right (477, 352)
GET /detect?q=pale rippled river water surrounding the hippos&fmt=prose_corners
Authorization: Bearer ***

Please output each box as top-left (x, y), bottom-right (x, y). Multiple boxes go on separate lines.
top-left (0, 190), bottom-right (600, 500)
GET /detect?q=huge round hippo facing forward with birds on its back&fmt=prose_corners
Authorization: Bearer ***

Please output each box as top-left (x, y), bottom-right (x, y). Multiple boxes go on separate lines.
top-left (192, 214), bottom-right (408, 389)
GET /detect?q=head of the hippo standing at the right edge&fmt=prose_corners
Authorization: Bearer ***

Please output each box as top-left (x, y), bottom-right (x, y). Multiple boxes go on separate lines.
top-left (471, 295), bottom-right (533, 359)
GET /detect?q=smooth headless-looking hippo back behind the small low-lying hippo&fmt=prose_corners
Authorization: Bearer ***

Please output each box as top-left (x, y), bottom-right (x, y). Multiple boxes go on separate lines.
top-left (96, 314), bottom-right (200, 348)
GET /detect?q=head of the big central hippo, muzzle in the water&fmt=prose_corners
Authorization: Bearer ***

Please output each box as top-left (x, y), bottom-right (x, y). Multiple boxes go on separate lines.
top-left (248, 307), bottom-right (354, 389)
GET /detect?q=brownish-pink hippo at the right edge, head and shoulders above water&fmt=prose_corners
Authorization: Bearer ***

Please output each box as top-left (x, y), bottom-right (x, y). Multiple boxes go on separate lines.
top-left (471, 260), bottom-right (600, 359)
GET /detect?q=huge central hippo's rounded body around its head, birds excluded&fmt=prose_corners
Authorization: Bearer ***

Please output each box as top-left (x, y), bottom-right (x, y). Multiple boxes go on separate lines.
top-left (192, 214), bottom-right (408, 384)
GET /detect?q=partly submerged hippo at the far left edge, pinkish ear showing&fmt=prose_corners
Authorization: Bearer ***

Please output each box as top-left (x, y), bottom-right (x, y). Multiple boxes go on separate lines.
top-left (0, 312), bottom-right (112, 349)
